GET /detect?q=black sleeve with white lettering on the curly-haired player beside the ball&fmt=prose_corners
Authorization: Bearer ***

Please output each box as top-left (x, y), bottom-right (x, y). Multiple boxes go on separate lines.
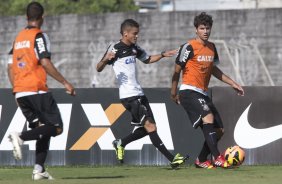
top-left (175, 43), bottom-right (194, 68)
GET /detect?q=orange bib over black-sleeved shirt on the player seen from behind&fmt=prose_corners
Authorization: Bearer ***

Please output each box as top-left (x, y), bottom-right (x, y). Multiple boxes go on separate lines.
top-left (11, 27), bottom-right (51, 93)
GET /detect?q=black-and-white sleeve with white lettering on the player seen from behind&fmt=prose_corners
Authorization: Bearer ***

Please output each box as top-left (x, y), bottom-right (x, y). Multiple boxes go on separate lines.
top-left (35, 33), bottom-right (51, 60)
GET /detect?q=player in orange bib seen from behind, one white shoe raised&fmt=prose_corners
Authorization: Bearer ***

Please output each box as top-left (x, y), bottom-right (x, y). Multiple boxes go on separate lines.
top-left (8, 2), bottom-right (75, 180)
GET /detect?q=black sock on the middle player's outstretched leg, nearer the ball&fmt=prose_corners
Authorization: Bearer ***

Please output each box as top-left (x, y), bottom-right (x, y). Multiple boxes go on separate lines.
top-left (149, 131), bottom-right (174, 162)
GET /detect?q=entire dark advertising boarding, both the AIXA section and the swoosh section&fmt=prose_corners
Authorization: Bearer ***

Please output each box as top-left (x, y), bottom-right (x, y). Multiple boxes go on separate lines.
top-left (0, 87), bottom-right (282, 165)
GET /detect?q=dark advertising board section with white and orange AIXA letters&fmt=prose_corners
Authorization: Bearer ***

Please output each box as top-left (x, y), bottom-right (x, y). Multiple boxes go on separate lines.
top-left (0, 88), bottom-right (203, 165)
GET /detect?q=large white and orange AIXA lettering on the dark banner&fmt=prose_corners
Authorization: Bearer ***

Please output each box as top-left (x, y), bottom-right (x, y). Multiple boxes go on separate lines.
top-left (0, 103), bottom-right (174, 151)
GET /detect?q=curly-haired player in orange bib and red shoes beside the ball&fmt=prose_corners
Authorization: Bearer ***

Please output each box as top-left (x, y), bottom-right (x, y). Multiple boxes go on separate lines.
top-left (171, 12), bottom-right (244, 168)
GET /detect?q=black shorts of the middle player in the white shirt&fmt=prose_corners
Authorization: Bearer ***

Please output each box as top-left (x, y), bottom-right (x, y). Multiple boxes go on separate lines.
top-left (120, 96), bottom-right (155, 126)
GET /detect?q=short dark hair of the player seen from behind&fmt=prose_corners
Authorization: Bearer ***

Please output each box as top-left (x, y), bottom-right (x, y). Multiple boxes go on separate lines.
top-left (26, 2), bottom-right (44, 21)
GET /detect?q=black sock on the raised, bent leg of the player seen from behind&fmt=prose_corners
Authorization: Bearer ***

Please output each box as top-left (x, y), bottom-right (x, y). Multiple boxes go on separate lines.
top-left (20, 125), bottom-right (57, 141)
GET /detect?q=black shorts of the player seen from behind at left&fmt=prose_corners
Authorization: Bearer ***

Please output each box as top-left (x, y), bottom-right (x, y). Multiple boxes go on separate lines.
top-left (17, 93), bottom-right (63, 128)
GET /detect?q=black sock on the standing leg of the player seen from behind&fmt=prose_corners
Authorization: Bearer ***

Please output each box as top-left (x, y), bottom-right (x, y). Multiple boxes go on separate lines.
top-left (35, 137), bottom-right (51, 172)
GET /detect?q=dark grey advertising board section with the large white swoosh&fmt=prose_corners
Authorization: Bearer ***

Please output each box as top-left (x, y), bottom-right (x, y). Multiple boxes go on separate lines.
top-left (212, 86), bottom-right (282, 165)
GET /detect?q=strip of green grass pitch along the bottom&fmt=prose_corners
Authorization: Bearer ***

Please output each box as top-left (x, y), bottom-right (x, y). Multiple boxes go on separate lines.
top-left (0, 166), bottom-right (282, 184)
